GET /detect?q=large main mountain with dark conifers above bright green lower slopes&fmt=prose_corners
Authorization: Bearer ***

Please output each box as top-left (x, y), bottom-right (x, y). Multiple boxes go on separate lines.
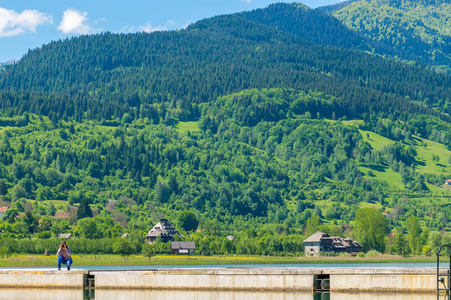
top-left (0, 2), bottom-right (451, 248)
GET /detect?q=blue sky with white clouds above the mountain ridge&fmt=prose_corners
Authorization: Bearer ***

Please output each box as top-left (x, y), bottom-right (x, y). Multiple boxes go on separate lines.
top-left (0, 0), bottom-right (340, 62)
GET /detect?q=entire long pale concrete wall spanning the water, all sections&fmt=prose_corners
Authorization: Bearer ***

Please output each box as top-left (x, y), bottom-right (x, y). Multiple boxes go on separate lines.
top-left (0, 267), bottom-right (449, 293)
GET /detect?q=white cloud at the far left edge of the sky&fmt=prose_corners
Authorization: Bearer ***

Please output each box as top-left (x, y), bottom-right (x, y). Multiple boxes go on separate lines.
top-left (0, 7), bottom-right (53, 37)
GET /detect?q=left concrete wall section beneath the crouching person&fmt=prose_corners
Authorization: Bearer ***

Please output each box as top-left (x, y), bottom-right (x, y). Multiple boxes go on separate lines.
top-left (0, 269), bottom-right (88, 289)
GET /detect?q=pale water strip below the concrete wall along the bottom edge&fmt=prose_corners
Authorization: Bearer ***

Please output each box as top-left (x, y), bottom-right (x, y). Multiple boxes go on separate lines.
top-left (0, 289), bottom-right (449, 300)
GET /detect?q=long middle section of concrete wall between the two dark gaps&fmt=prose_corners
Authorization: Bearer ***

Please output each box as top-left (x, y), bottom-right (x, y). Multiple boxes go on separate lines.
top-left (90, 268), bottom-right (319, 291)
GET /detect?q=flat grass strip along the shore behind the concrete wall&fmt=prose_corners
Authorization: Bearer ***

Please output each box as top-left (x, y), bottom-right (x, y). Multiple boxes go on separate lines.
top-left (0, 254), bottom-right (446, 268)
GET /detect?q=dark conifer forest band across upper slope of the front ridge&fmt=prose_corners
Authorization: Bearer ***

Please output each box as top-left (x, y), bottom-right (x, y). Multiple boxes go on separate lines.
top-left (0, 7), bottom-right (451, 125)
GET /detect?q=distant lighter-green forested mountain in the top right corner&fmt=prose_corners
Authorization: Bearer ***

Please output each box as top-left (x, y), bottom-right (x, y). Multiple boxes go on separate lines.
top-left (321, 0), bottom-right (451, 72)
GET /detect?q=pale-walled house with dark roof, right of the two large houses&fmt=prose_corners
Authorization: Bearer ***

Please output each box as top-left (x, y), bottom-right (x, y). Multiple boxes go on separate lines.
top-left (304, 231), bottom-right (362, 256)
